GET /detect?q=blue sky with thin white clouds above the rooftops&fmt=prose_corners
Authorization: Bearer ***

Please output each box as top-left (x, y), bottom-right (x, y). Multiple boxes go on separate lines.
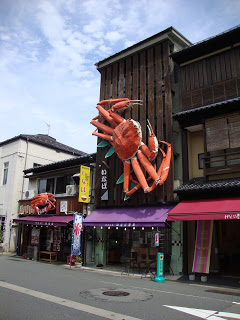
top-left (0, 0), bottom-right (240, 153)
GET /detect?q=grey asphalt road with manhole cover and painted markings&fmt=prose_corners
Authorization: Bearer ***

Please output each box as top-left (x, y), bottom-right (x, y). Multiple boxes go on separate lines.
top-left (0, 255), bottom-right (240, 320)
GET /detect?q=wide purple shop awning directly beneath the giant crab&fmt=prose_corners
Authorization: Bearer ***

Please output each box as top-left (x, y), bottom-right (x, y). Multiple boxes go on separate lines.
top-left (83, 205), bottom-right (173, 227)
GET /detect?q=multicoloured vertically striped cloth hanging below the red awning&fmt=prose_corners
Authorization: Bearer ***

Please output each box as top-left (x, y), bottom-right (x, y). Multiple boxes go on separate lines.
top-left (192, 220), bottom-right (213, 273)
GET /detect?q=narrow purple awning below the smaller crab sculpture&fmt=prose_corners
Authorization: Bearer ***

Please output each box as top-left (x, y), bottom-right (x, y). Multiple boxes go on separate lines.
top-left (13, 216), bottom-right (73, 227)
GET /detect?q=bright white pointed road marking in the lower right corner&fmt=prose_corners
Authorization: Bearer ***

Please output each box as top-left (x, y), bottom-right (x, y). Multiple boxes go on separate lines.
top-left (164, 305), bottom-right (240, 320)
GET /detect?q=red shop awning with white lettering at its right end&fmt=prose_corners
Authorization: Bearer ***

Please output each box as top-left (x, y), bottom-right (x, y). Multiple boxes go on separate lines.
top-left (167, 197), bottom-right (240, 221)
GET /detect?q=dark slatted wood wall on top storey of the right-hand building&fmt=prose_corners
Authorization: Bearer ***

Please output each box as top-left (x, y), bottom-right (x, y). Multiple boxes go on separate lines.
top-left (180, 47), bottom-right (240, 110)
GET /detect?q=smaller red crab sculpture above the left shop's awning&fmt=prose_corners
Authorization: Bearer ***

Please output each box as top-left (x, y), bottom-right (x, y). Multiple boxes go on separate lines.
top-left (31, 193), bottom-right (56, 214)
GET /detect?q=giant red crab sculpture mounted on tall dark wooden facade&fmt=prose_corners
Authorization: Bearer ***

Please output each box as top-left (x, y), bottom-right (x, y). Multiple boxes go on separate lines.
top-left (91, 98), bottom-right (172, 198)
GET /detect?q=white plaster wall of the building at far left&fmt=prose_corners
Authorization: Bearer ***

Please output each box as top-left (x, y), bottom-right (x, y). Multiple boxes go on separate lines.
top-left (0, 139), bottom-right (79, 251)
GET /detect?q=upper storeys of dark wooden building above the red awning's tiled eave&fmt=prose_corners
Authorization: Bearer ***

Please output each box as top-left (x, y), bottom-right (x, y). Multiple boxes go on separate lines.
top-left (173, 27), bottom-right (240, 186)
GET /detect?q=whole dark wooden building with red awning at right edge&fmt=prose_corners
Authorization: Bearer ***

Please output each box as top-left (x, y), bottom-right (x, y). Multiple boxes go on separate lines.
top-left (168, 26), bottom-right (240, 275)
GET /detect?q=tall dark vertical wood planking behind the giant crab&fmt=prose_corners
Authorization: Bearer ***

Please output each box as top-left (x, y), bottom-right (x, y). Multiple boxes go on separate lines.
top-left (95, 41), bottom-right (173, 207)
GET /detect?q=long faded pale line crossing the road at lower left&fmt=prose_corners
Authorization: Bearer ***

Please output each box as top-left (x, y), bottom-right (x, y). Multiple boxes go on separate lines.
top-left (0, 281), bottom-right (141, 320)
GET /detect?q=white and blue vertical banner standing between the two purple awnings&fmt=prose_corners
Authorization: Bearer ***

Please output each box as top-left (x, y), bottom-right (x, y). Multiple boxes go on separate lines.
top-left (71, 213), bottom-right (83, 257)
